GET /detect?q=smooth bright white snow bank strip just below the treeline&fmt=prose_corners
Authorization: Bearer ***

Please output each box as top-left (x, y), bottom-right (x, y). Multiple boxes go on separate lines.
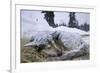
top-left (24, 26), bottom-right (89, 38)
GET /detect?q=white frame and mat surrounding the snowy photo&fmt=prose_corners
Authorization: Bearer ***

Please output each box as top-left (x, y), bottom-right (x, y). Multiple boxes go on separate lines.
top-left (11, 2), bottom-right (96, 73)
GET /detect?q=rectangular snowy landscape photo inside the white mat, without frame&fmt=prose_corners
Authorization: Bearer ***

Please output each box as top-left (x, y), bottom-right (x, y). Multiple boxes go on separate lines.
top-left (20, 9), bottom-right (91, 63)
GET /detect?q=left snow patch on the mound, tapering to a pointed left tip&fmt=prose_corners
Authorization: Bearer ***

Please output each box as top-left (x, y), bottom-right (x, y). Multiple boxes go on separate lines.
top-left (25, 31), bottom-right (52, 46)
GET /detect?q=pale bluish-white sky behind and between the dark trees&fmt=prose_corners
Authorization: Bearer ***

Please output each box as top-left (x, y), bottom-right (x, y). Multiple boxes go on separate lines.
top-left (21, 10), bottom-right (90, 34)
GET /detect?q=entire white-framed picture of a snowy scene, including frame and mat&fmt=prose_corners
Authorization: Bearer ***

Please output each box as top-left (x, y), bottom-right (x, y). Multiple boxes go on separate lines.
top-left (10, 0), bottom-right (96, 73)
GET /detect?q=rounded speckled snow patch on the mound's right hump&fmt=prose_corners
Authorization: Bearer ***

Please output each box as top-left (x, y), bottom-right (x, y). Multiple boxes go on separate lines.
top-left (54, 31), bottom-right (83, 50)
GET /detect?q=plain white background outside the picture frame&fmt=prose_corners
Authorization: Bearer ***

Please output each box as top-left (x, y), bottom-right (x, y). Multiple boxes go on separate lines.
top-left (0, 0), bottom-right (100, 73)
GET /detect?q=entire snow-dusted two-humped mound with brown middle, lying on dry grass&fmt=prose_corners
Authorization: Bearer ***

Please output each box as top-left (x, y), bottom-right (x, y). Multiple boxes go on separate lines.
top-left (24, 31), bottom-right (89, 60)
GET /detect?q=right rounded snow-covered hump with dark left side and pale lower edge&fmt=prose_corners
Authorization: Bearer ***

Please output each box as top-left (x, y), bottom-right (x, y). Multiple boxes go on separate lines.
top-left (50, 31), bottom-right (89, 60)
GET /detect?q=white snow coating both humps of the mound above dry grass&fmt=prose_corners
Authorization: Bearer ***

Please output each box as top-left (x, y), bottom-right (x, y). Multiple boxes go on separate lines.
top-left (25, 31), bottom-right (83, 50)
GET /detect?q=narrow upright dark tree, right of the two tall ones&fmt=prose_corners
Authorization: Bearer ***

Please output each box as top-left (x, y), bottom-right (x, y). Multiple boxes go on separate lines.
top-left (68, 12), bottom-right (78, 28)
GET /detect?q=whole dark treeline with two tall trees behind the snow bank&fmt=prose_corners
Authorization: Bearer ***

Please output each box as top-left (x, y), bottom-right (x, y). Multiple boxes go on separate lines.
top-left (41, 11), bottom-right (90, 31)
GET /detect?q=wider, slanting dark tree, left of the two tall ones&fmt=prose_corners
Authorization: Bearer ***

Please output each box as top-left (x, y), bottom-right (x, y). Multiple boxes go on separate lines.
top-left (42, 11), bottom-right (55, 28)
